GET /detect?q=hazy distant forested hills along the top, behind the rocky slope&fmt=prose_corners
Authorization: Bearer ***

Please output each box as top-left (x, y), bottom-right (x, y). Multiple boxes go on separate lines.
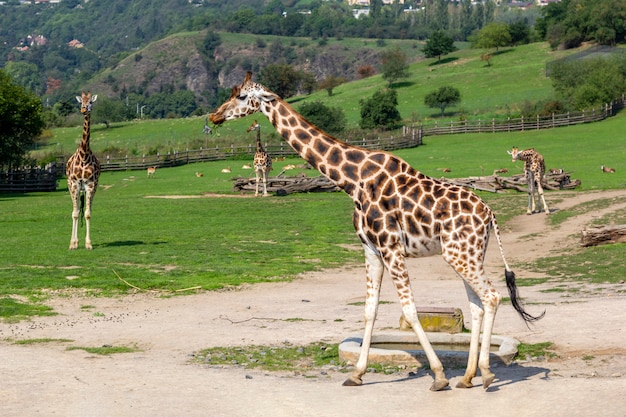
top-left (0, 0), bottom-right (626, 122)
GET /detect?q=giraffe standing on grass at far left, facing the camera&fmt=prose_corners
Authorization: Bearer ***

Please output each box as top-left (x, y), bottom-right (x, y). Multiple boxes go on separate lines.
top-left (65, 91), bottom-right (100, 250)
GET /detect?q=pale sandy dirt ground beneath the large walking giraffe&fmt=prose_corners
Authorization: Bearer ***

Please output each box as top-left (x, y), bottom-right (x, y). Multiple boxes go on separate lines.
top-left (0, 191), bottom-right (626, 417)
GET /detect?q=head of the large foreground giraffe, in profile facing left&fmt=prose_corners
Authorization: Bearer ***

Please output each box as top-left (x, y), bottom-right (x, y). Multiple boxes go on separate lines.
top-left (209, 72), bottom-right (278, 125)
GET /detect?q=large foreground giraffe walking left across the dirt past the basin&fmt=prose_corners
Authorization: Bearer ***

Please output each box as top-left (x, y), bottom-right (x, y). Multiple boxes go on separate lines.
top-left (210, 73), bottom-right (542, 391)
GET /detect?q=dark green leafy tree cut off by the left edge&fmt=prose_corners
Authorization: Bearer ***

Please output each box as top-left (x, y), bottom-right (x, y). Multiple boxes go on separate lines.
top-left (0, 70), bottom-right (44, 170)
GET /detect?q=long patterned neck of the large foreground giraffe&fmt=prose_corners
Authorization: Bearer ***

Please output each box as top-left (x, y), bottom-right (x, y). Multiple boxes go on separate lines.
top-left (261, 98), bottom-right (369, 195)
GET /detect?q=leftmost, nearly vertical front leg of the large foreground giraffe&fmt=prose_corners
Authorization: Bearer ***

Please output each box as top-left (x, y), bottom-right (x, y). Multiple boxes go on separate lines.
top-left (343, 245), bottom-right (384, 387)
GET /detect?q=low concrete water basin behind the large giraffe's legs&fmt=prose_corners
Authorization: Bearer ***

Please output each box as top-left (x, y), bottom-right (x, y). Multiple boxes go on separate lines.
top-left (339, 330), bottom-right (519, 367)
